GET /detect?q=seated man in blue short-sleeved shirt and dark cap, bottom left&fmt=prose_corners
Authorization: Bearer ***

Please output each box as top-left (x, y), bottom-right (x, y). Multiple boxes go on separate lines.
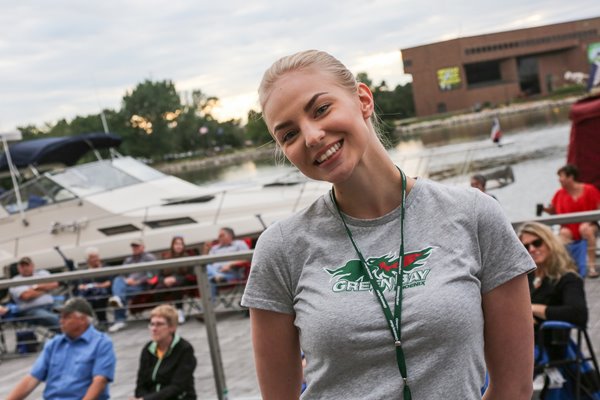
top-left (8, 297), bottom-right (116, 400)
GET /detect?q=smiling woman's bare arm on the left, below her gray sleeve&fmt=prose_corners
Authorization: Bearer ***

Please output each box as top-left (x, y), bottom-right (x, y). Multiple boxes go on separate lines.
top-left (250, 308), bottom-right (302, 400)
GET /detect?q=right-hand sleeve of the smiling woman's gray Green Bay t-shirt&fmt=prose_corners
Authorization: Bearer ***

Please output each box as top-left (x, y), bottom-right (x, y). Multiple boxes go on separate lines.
top-left (475, 195), bottom-right (535, 293)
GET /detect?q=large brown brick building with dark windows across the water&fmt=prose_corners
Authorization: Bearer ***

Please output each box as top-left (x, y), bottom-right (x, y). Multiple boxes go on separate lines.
top-left (401, 17), bottom-right (600, 116)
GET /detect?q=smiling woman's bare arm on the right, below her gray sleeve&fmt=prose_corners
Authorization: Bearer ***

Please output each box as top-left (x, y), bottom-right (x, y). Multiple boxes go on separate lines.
top-left (483, 275), bottom-right (533, 400)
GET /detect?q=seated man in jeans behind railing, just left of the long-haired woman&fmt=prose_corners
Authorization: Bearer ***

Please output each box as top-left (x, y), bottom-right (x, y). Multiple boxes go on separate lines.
top-left (108, 239), bottom-right (156, 332)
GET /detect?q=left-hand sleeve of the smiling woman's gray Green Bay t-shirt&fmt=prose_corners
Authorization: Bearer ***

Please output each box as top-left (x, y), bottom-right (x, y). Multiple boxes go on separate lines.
top-left (242, 223), bottom-right (294, 314)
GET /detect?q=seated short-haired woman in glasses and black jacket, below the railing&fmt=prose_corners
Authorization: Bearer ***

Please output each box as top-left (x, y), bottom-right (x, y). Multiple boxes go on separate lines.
top-left (130, 304), bottom-right (196, 400)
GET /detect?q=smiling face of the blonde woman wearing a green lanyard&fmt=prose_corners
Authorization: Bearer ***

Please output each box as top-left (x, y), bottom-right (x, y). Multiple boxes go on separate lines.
top-left (263, 69), bottom-right (378, 184)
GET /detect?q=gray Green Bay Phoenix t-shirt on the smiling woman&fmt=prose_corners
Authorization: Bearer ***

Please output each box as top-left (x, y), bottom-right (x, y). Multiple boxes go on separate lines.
top-left (242, 179), bottom-right (535, 400)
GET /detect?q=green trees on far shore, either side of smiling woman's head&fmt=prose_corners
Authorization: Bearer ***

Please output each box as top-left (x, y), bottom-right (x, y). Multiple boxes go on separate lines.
top-left (18, 72), bottom-right (414, 161)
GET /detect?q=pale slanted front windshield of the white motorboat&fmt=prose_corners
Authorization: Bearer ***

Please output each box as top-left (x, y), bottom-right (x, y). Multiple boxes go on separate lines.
top-left (52, 157), bottom-right (164, 197)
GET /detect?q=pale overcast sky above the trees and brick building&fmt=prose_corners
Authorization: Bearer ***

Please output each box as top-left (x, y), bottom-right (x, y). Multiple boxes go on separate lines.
top-left (0, 0), bottom-right (600, 132)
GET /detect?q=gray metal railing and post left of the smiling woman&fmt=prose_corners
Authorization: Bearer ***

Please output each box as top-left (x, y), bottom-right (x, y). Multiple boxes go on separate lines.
top-left (0, 250), bottom-right (254, 400)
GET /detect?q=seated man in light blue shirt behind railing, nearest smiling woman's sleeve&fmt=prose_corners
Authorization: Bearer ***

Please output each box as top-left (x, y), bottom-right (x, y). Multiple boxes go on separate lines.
top-left (203, 228), bottom-right (250, 300)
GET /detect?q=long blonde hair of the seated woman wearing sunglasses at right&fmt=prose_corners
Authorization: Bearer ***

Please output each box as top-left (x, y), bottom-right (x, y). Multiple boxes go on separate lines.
top-left (519, 222), bottom-right (578, 280)
